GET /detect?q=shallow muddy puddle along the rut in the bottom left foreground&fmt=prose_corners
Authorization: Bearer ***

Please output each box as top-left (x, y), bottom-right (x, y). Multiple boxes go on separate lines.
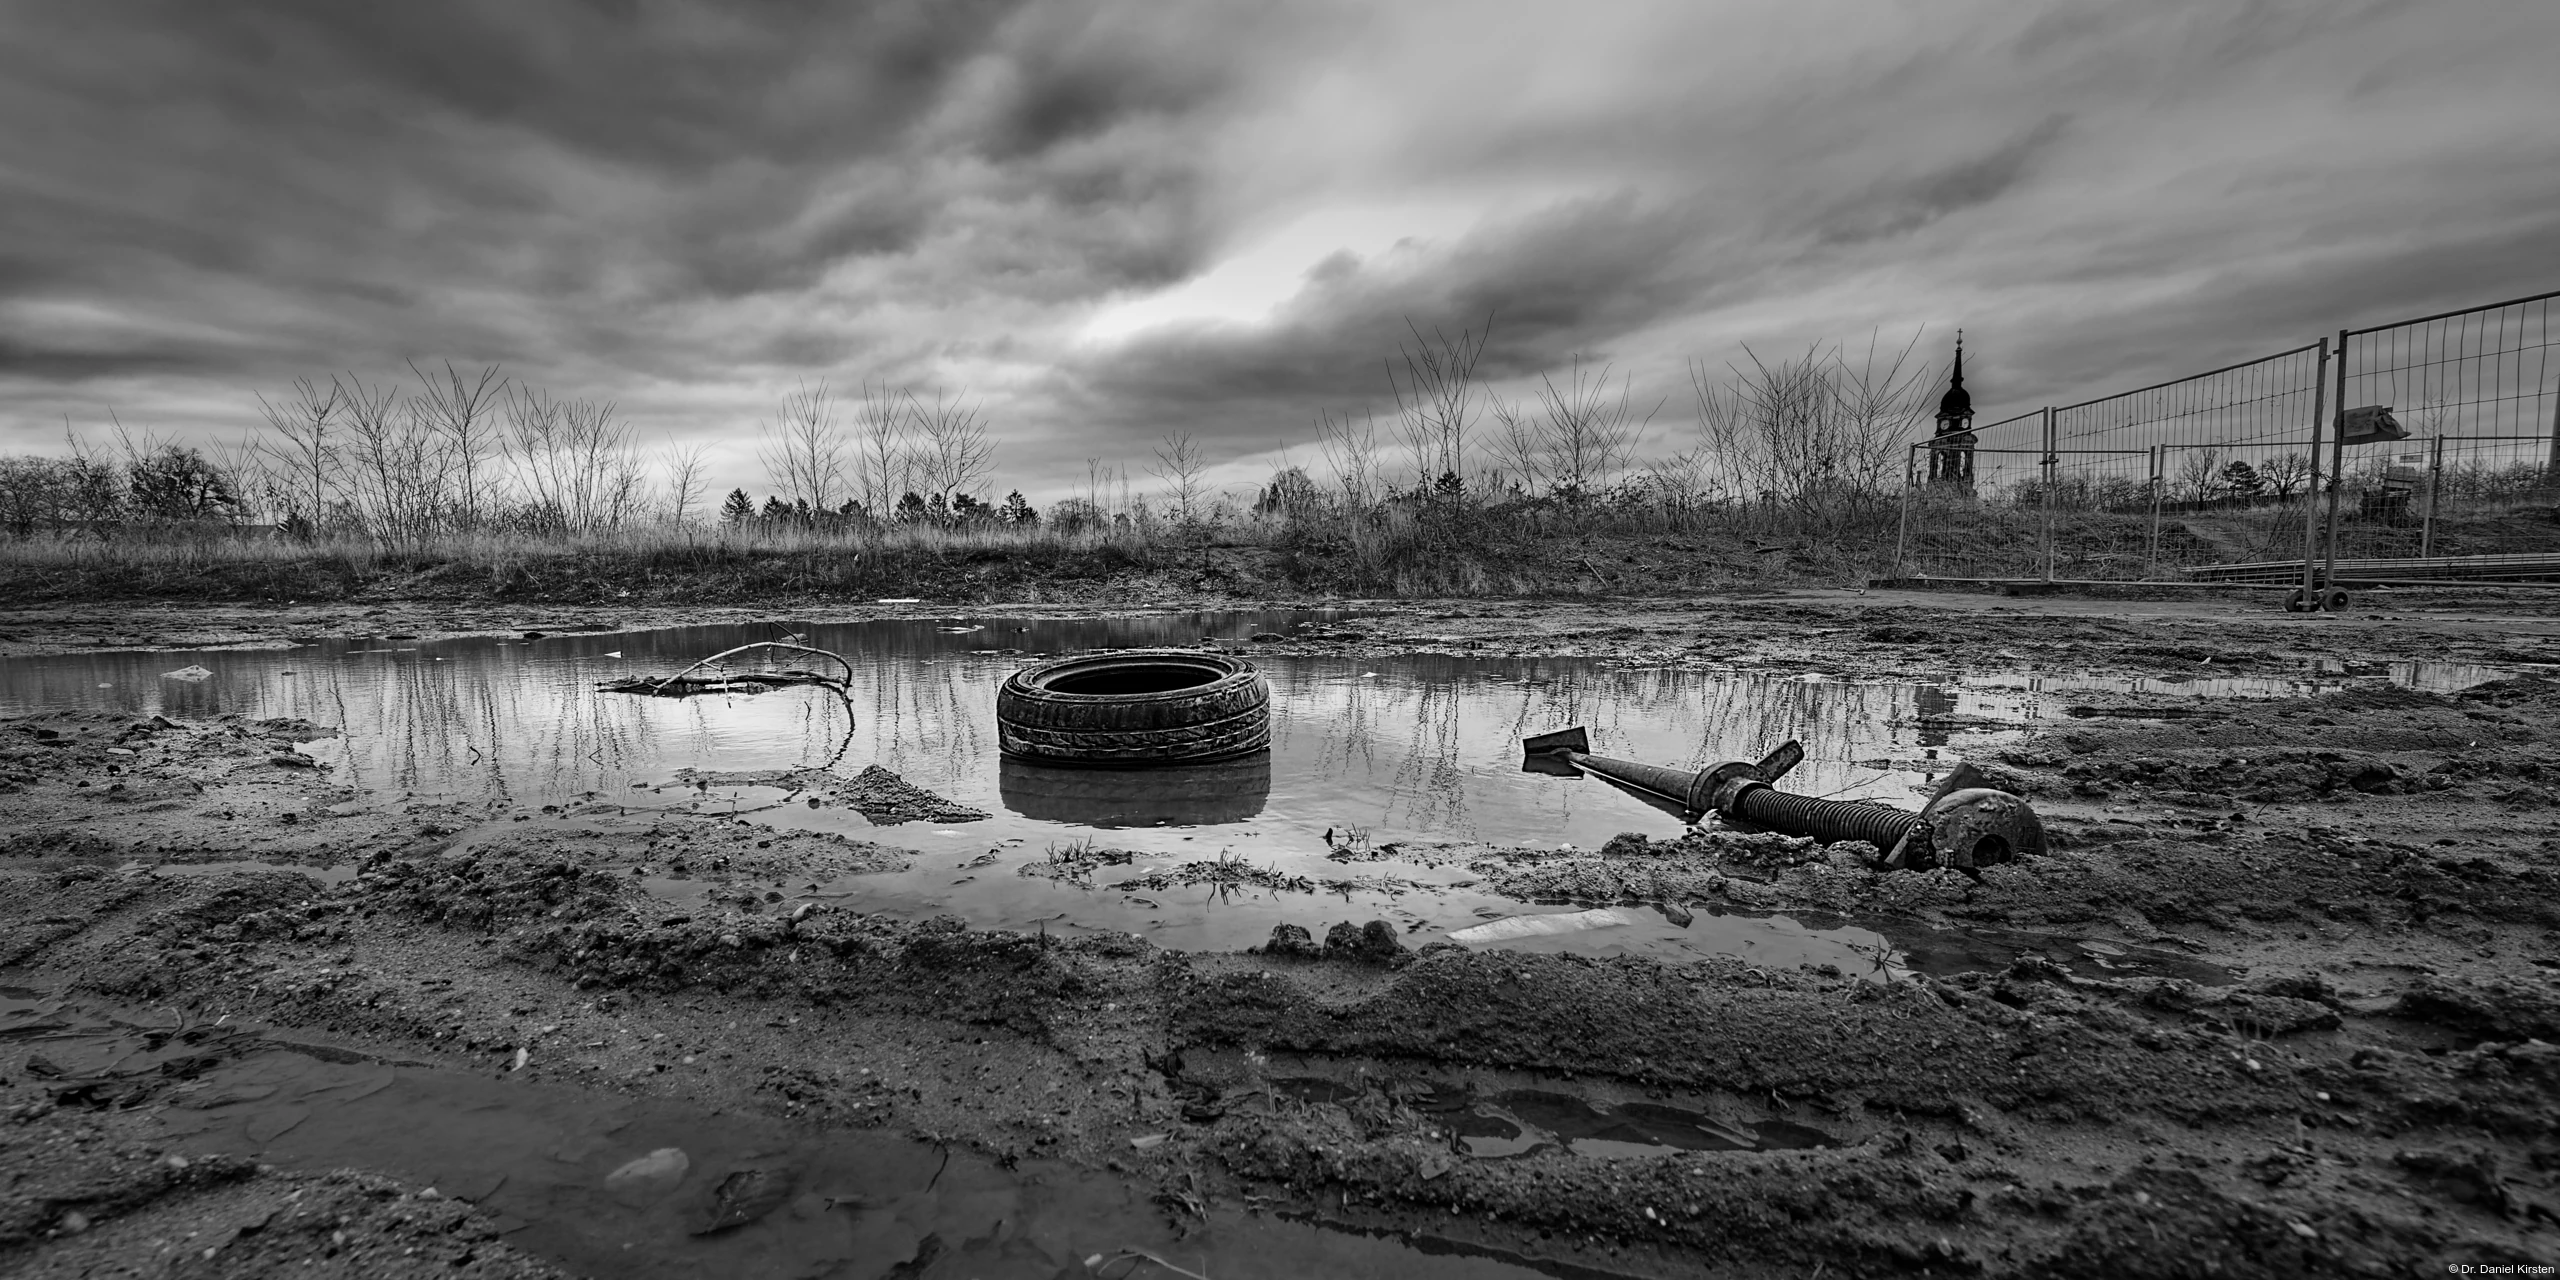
top-left (0, 988), bottom-right (1592, 1280)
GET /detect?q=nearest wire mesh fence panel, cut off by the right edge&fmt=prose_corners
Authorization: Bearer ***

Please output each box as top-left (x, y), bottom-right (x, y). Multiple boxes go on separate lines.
top-left (2322, 292), bottom-right (2560, 584)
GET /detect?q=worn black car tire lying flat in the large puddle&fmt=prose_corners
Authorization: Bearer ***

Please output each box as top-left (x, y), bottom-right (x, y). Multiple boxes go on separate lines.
top-left (996, 650), bottom-right (1272, 768)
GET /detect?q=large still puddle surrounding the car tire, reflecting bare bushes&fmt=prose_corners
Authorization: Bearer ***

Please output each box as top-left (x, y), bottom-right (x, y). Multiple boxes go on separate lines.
top-left (0, 612), bottom-right (2499, 973)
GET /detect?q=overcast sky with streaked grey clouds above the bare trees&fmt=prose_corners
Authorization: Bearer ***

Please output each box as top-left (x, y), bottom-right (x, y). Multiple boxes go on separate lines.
top-left (0, 0), bottom-right (2560, 497)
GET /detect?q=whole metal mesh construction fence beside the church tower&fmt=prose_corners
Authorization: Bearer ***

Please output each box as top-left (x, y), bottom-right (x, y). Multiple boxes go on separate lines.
top-left (1894, 292), bottom-right (2560, 604)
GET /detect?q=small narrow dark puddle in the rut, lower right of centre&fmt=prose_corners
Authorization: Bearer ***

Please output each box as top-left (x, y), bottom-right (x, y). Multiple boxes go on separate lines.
top-left (1270, 1075), bottom-right (1841, 1160)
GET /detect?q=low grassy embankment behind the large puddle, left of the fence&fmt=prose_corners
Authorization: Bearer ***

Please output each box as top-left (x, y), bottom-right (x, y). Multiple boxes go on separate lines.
top-left (0, 496), bottom-right (1925, 604)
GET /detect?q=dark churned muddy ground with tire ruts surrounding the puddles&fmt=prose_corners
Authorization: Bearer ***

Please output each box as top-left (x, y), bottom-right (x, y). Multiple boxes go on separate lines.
top-left (0, 591), bottom-right (2560, 1277)
